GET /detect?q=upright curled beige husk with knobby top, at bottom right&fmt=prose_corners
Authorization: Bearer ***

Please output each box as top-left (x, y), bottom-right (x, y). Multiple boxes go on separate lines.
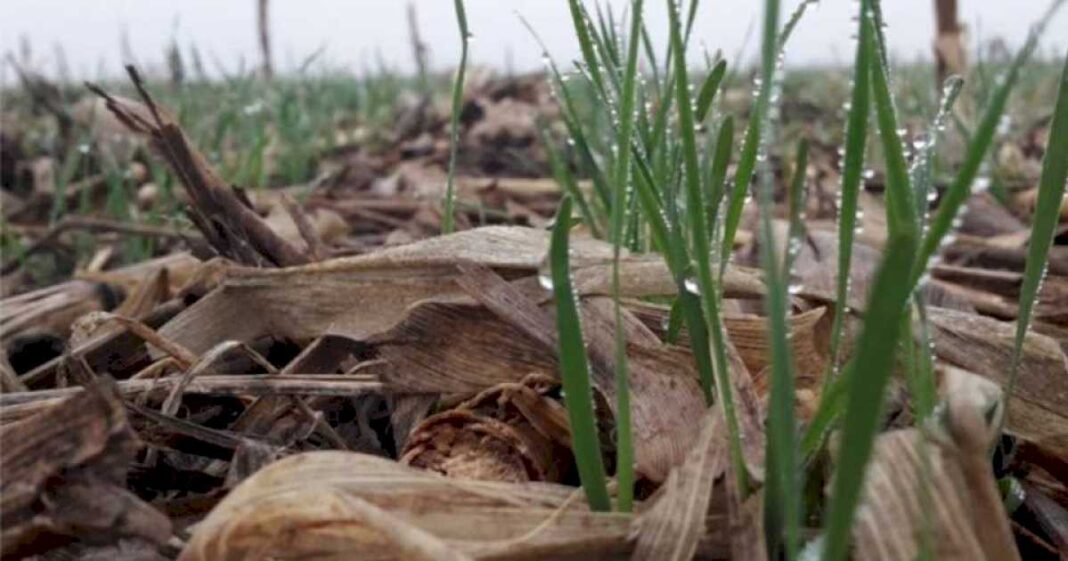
top-left (853, 368), bottom-right (1020, 561)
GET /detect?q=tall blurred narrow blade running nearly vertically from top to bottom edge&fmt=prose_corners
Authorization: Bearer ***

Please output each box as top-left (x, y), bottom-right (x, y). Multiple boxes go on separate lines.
top-left (753, 0), bottom-right (807, 560)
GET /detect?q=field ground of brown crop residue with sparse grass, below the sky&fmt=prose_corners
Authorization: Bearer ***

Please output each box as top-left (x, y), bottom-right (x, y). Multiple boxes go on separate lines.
top-left (0, 30), bottom-right (1068, 561)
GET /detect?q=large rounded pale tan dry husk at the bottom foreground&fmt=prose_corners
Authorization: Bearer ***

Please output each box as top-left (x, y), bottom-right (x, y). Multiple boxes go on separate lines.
top-left (179, 452), bottom-right (630, 561)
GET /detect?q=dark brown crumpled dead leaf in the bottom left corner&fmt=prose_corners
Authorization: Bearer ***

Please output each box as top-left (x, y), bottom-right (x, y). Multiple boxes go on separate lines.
top-left (0, 380), bottom-right (171, 558)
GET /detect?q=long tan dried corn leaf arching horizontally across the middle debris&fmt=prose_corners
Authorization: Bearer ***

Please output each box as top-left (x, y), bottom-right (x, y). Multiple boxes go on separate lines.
top-left (154, 227), bottom-right (611, 352)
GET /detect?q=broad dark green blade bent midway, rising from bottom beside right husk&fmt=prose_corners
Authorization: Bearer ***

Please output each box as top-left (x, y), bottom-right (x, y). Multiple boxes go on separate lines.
top-left (823, 9), bottom-right (917, 561)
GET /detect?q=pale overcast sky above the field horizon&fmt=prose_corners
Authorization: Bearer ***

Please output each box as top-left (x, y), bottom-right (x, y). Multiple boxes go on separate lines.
top-left (0, 0), bottom-right (1068, 78)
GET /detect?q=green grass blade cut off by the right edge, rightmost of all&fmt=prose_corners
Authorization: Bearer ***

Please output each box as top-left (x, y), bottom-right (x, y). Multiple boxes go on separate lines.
top-left (1002, 51), bottom-right (1068, 410)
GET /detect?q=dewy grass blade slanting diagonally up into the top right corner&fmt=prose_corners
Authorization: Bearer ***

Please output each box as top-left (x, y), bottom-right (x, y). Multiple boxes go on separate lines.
top-left (912, 0), bottom-right (1064, 284)
